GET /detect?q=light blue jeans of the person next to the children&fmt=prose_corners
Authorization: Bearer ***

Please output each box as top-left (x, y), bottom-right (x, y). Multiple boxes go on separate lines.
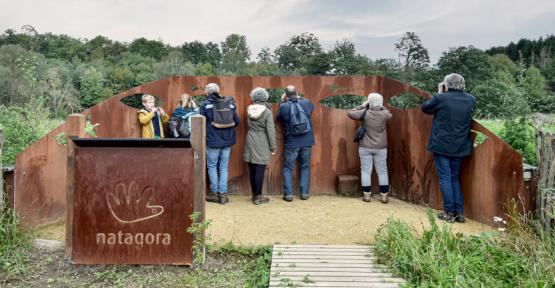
top-left (206, 146), bottom-right (231, 194)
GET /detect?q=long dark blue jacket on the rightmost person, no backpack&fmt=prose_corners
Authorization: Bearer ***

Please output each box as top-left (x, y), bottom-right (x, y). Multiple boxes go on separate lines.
top-left (422, 89), bottom-right (476, 157)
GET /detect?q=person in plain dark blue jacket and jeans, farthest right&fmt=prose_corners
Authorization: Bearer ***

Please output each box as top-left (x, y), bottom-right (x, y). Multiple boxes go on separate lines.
top-left (422, 73), bottom-right (476, 223)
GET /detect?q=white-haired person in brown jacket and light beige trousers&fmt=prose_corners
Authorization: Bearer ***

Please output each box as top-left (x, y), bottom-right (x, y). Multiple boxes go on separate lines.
top-left (348, 93), bottom-right (392, 204)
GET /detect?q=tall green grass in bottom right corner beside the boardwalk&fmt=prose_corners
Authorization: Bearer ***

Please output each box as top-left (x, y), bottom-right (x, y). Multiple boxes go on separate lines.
top-left (376, 210), bottom-right (555, 287)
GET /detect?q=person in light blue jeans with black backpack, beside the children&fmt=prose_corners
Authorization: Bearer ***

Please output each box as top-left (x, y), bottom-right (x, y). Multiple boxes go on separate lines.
top-left (200, 83), bottom-right (239, 204)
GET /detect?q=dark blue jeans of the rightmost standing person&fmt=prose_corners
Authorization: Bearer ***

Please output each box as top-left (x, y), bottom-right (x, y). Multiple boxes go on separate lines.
top-left (434, 154), bottom-right (463, 213)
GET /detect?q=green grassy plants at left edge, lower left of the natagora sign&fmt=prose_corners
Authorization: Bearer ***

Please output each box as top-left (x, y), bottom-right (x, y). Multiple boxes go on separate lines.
top-left (0, 206), bottom-right (29, 276)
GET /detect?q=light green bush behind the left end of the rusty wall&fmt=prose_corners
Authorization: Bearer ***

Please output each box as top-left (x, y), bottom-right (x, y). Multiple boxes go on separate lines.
top-left (0, 101), bottom-right (63, 165)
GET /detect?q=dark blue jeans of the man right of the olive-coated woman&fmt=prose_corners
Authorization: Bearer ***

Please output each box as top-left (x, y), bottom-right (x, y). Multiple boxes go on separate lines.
top-left (283, 146), bottom-right (312, 196)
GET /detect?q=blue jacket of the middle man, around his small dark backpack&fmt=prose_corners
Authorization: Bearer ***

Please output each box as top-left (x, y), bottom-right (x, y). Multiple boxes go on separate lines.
top-left (276, 98), bottom-right (314, 148)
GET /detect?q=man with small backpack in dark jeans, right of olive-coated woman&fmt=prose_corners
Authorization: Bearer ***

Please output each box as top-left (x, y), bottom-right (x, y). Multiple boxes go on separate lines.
top-left (276, 85), bottom-right (314, 202)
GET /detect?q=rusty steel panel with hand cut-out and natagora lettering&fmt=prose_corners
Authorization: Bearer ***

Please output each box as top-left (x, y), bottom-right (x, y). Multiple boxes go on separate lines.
top-left (72, 147), bottom-right (195, 265)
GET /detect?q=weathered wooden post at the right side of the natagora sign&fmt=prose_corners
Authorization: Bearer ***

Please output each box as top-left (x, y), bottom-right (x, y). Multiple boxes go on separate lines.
top-left (190, 115), bottom-right (206, 259)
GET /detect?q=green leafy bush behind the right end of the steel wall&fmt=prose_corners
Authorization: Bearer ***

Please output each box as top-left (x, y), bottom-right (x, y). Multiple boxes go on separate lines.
top-left (501, 117), bottom-right (538, 166)
